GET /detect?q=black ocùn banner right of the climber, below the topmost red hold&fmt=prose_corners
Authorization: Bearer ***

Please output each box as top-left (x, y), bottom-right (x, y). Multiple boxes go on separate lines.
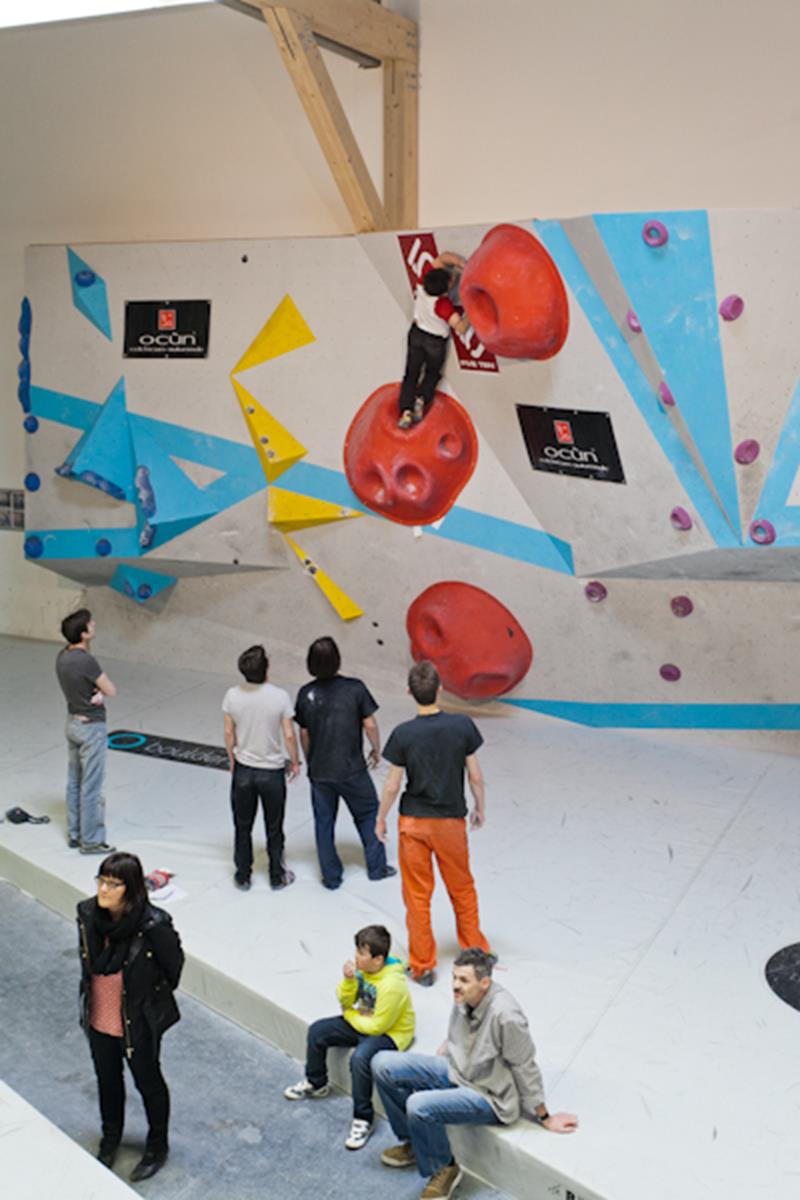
top-left (517, 404), bottom-right (625, 484)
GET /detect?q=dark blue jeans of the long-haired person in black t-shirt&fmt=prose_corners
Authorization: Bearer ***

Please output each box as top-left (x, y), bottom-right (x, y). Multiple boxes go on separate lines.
top-left (311, 770), bottom-right (386, 888)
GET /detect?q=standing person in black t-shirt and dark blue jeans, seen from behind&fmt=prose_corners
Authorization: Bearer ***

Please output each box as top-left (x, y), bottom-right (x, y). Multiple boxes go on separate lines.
top-left (295, 637), bottom-right (397, 890)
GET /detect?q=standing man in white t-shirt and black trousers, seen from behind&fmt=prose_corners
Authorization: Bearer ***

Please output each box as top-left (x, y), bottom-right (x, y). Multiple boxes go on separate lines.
top-left (222, 646), bottom-right (300, 892)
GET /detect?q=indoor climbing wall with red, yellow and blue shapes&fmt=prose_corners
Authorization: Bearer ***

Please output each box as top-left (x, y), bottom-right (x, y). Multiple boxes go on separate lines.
top-left (19, 211), bottom-right (800, 728)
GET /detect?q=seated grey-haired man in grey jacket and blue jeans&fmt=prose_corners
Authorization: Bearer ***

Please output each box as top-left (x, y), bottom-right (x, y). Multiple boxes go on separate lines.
top-left (372, 948), bottom-right (578, 1200)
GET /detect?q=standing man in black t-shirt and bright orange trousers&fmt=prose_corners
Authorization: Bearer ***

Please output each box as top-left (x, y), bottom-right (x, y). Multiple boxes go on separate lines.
top-left (375, 660), bottom-right (489, 988)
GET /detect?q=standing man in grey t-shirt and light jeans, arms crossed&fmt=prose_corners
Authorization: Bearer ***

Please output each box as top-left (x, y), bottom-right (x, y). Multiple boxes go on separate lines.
top-left (55, 608), bottom-right (116, 854)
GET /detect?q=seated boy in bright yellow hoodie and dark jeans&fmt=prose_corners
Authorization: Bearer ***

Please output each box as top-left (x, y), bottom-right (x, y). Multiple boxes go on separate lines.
top-left (283, 925), bottom-right (415, 1150)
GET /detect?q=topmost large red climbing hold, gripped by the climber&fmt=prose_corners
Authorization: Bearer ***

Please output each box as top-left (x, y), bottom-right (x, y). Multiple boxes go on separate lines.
top-left (459, 224), bottom-right (570, 359)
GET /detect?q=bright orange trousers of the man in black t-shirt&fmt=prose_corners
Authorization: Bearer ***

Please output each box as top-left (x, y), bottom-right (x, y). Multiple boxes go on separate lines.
top-left (397, 816), bottom-right (489, 974)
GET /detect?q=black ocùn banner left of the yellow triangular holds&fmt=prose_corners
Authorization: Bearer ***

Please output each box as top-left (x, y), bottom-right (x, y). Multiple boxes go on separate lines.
top-left (122, 300), bottom-right (211, 359)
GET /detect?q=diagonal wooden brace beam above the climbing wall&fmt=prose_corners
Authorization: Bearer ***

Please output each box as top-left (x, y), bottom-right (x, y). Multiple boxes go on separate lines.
top-left (261, 5), bottom-right (389, 233)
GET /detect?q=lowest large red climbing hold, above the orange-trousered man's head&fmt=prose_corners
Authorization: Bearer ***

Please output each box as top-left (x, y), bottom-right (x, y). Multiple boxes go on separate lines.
top-left (405, 582), bottom-right (534, 700)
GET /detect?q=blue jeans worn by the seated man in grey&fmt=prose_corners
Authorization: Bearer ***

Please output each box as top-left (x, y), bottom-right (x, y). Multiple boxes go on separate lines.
top-left (372, 1051), bottom-right (500, 1176)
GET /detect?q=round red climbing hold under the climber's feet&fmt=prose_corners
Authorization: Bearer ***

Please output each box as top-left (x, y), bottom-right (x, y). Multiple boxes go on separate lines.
top-left (344, 383), bottom-right (477, 526)
